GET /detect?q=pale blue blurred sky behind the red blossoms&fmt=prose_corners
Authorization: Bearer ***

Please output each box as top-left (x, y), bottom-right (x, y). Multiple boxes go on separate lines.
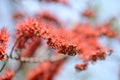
top-left (0, 0), bottom-right (120, 80)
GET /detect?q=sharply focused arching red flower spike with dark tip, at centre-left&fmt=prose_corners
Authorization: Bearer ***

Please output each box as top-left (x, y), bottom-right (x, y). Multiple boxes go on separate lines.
top-left (16, 19), bottom-right (76, 55)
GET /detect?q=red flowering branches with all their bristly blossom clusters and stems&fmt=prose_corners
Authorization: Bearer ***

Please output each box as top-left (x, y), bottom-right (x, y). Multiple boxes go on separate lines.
top-left (0, 0), bottom-right (117, 80)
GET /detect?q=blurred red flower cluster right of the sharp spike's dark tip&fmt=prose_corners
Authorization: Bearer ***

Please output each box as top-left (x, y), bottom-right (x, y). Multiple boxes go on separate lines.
top-left (73, 24), bottom-right (115, 70)
